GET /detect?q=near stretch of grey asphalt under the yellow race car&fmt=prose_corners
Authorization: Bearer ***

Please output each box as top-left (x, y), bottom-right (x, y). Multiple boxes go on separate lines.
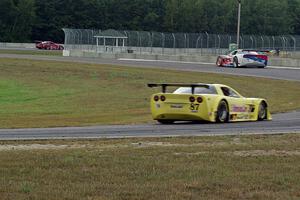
top-left (0, 112), bottom-right (300, 140)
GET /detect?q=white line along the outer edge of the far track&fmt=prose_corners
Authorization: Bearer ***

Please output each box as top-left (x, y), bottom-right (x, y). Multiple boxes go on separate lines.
top-left (118, 58), bottom-right (300, 70)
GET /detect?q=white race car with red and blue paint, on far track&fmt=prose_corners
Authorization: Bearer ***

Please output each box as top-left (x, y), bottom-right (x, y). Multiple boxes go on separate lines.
top-left (216, 49), bottom-right (268, 68)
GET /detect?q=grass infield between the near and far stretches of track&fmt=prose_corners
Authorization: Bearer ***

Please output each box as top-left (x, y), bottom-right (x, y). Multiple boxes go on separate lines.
top-left (0, 59), bottom-right (300, 128)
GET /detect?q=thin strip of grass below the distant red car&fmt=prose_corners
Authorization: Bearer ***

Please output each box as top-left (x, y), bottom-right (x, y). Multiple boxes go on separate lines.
top-left (0, 49), bottom-right (62, 56)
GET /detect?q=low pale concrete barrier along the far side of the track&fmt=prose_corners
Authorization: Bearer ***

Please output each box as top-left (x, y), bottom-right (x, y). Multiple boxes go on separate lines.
top-left (0, 42), bottom-right (300, 68)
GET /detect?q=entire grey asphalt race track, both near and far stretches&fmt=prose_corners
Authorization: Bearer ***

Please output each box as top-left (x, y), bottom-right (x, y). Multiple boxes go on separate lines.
top-left (0, 54), bottom-right (300, 140)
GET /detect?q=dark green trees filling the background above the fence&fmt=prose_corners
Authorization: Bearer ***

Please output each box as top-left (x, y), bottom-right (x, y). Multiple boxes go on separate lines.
top-left (0, 0), bottom-right (300, 42)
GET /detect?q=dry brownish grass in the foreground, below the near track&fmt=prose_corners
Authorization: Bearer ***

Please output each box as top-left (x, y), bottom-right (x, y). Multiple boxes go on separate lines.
top-left (0, 134), bottom-right (300, 200)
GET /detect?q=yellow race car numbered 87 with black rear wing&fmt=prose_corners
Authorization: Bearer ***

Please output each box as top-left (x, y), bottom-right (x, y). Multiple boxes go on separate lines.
top-left (148, 83), bottom-right (272, 124)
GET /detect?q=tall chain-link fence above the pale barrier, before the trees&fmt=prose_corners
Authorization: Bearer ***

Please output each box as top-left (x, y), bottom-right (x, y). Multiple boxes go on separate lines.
top-left (63, 28), bottom-right (300, 55)
